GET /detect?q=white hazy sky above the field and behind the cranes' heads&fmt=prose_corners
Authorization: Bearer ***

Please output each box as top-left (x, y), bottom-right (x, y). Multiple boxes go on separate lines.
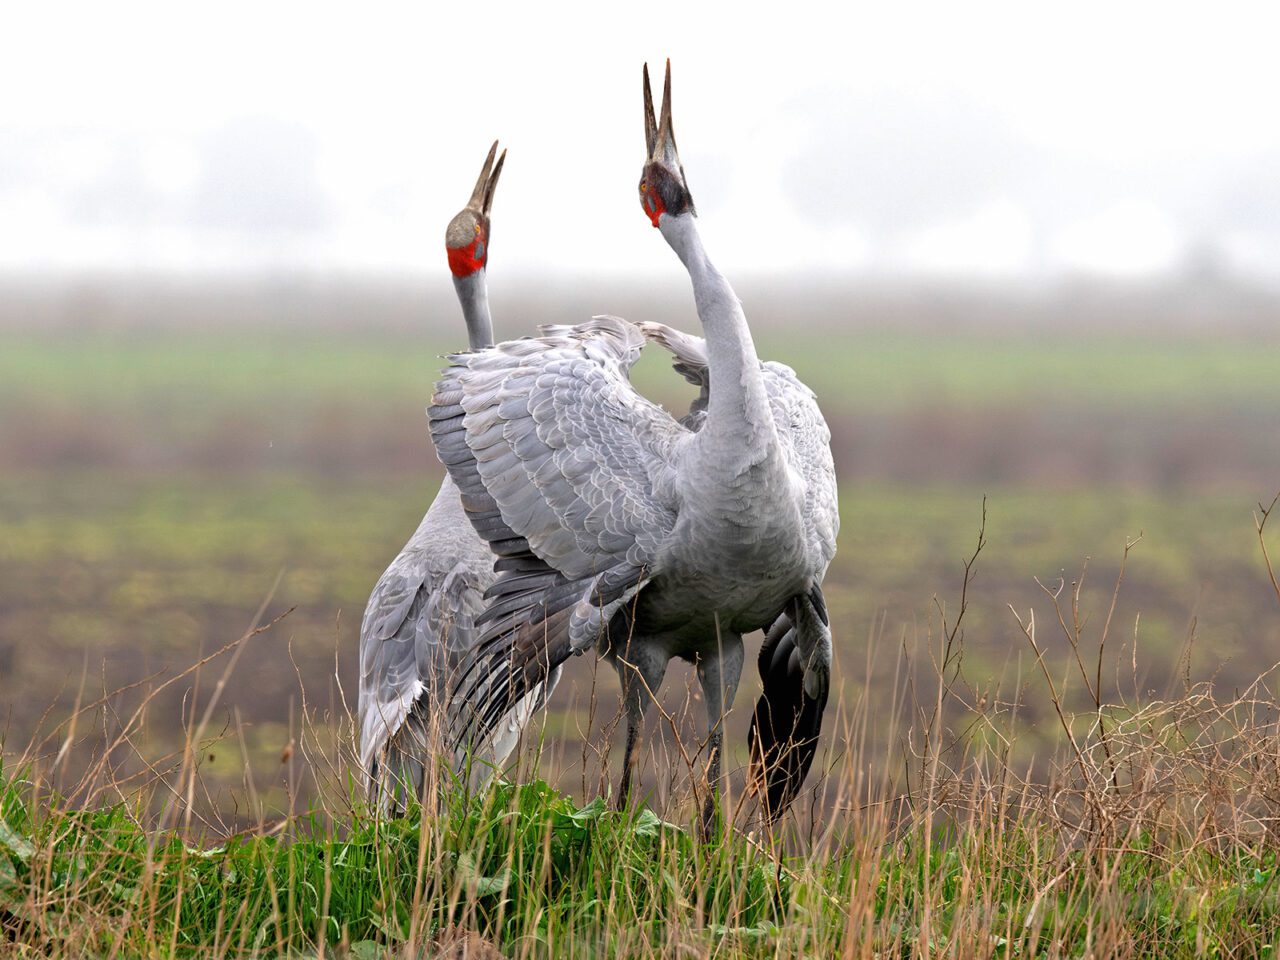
top-left (0, 1), bottom-right (1280, 282)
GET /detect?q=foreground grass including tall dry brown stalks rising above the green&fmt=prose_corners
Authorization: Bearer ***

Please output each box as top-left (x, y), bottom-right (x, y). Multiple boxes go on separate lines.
top-left (0, 506), bottom-right (1280, 960)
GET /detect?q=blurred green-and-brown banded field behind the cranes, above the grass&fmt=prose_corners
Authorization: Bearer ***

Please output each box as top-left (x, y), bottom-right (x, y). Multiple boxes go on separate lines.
top-left (0, 330), bottom-right (1280, 804)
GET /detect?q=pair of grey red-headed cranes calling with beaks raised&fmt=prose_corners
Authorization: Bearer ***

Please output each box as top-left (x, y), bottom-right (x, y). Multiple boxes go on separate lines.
top-left (360, 61), bottom-right (840, 836)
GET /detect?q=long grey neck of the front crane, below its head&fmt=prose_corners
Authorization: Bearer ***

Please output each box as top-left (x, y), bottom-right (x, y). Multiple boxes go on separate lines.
top-left (659, 214), bottom-right (777, 462)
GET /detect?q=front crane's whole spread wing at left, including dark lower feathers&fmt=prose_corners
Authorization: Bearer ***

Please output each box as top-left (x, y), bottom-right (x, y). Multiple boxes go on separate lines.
top-left (428, 316), bottom-right (691, 746)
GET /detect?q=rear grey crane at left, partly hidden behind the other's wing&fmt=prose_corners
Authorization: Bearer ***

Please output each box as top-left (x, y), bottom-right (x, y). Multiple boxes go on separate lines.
top-left (358, 142), bottom-right (558, 808)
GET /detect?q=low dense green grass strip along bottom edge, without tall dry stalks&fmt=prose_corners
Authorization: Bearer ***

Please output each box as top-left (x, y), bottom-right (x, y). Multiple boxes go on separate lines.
top-left (0, 721), bottom-right (1280, 960)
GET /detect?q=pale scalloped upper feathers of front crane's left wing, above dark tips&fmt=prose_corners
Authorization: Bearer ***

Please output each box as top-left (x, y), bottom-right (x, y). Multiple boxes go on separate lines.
top-left (429, 317), bottom-right (689, 579)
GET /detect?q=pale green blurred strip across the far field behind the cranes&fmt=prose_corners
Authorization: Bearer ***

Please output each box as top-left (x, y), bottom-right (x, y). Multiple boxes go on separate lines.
top-left (0, 328), bottom-right (1280, 416)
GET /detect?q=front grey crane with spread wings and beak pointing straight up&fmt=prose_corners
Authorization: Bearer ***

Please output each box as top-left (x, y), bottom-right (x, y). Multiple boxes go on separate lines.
top-left (428, 63), bottom-right (838, 836)
